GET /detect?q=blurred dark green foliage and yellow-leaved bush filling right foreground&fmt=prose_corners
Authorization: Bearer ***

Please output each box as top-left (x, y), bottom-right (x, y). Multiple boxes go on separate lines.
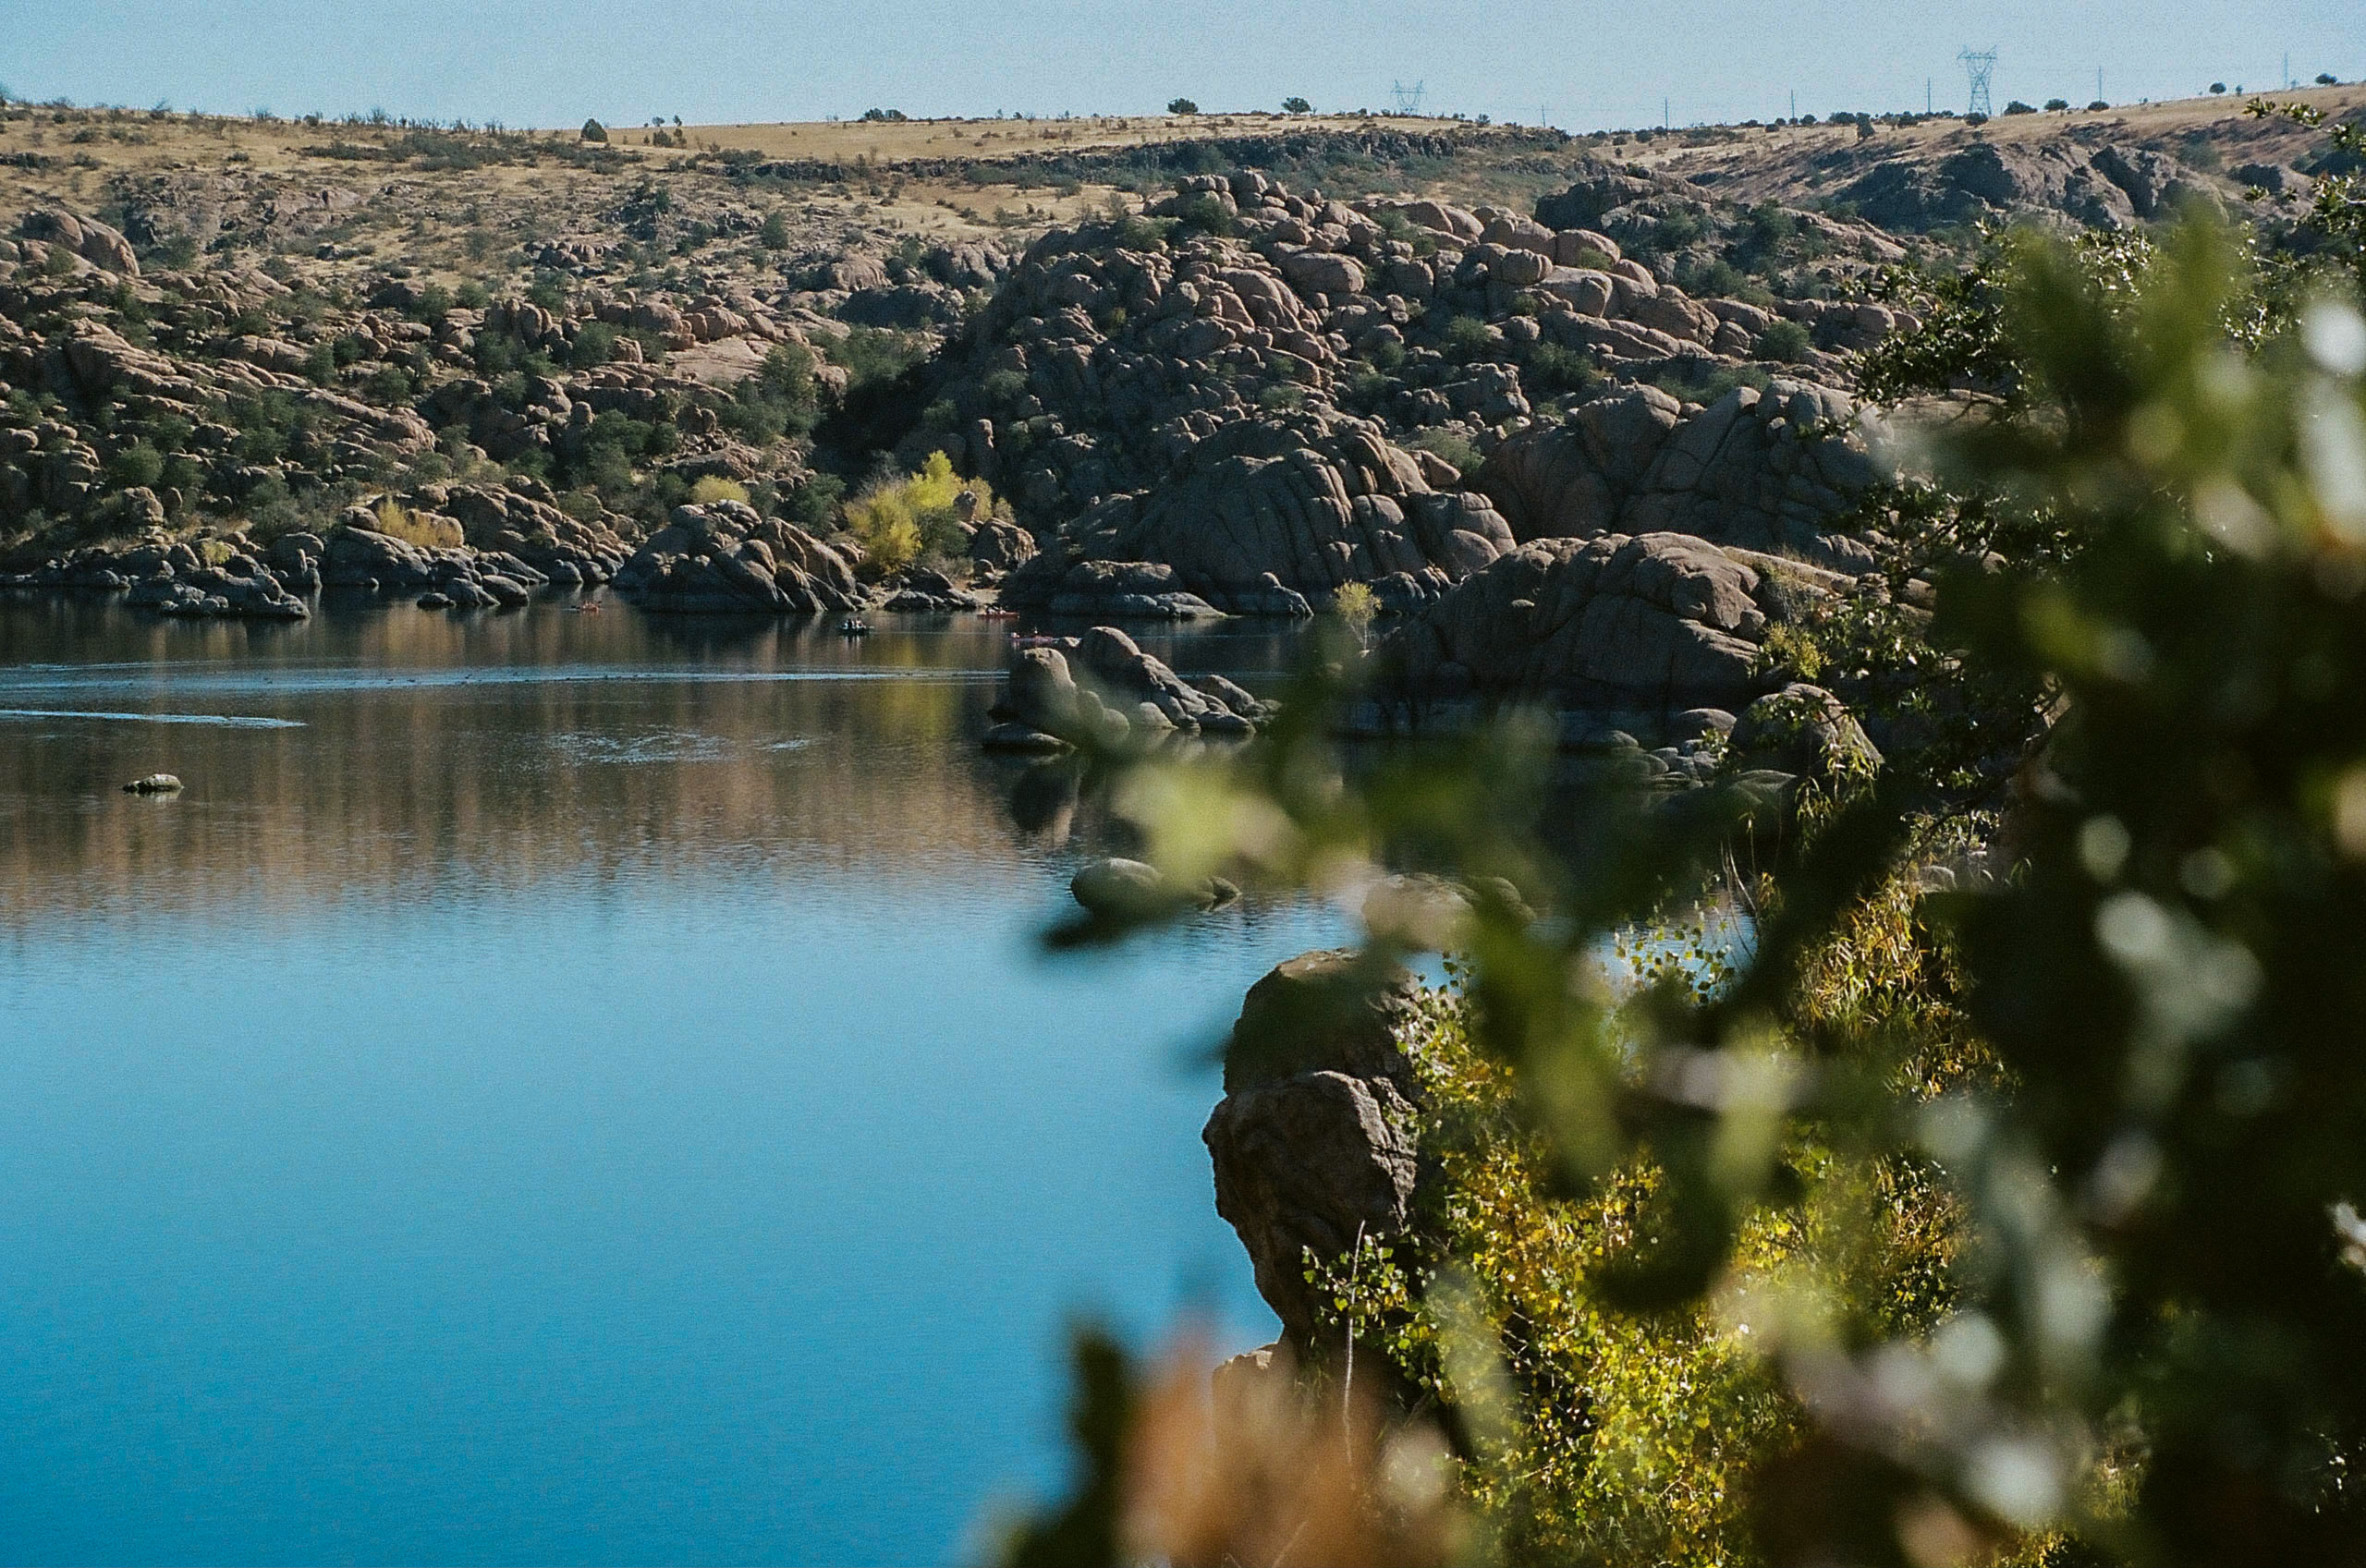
top-left (1021, 205), bottom-right (2366, 1565)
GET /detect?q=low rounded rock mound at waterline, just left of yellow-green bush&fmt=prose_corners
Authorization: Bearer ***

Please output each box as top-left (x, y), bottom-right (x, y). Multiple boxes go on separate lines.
top-left (616, 502), bottom-right (866, 614)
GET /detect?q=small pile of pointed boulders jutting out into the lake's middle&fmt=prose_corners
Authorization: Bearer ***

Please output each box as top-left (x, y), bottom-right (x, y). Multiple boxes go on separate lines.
top-left (984, 626), bottom-right (1268, 752)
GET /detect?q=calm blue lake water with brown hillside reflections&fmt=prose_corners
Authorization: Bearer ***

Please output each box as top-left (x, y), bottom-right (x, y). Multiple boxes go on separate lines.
top-left (0, 601), bottom-right (1342, 1563)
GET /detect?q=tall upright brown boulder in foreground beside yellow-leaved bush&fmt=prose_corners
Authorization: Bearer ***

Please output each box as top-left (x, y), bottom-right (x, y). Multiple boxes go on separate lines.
top-left (1200, 951), bottom-right (1420, 1362)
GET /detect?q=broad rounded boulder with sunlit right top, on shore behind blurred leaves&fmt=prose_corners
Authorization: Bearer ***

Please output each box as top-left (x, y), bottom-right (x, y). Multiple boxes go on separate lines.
top-left (1374, 534), bottom-right (1817, 714)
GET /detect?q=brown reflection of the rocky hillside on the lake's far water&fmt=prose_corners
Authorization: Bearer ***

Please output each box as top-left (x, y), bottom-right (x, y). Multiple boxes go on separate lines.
top-left (0, 601), bottom-right (1289, 922)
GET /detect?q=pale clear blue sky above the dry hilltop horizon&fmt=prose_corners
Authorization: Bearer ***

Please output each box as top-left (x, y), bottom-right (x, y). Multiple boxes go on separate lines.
top-left (0, 0), bottom-right (2366, 130)
